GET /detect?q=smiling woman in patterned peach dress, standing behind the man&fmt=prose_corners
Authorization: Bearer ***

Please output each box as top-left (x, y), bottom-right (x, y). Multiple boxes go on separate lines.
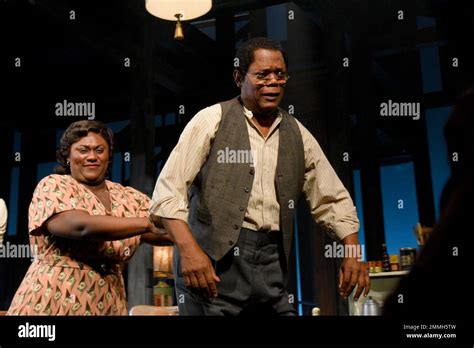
top-left (7, 121), bottom-right (171, 315)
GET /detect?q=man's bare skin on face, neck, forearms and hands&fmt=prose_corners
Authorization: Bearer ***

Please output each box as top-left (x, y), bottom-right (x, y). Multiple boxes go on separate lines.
top-left (162, 49), bottom-right (370, 300)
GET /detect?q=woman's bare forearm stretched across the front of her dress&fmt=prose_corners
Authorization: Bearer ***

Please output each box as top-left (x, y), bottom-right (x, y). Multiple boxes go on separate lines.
top-left (44, 210), bottom-right (163, 240)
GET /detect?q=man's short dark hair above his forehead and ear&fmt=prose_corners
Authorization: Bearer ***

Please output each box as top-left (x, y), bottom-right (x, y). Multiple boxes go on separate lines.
top-left (235, 37), bottom-right (288, 74)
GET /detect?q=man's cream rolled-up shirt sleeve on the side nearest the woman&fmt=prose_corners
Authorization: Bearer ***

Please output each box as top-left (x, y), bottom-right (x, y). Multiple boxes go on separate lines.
top-left (150, 104), bottom-right (221, 222)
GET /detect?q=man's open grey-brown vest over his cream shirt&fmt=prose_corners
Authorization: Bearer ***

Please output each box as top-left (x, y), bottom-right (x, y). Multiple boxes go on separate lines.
top-left (188, 98), bottom-right (305, 262)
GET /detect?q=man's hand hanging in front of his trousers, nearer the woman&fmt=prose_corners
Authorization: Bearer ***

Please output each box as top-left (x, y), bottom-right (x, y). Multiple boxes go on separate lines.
top-left (180, 244), bottom-right (220, 298)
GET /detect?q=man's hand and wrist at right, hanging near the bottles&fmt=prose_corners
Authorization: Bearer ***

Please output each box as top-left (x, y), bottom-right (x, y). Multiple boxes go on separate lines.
top-left (339, 234), bottom-right (370, 301)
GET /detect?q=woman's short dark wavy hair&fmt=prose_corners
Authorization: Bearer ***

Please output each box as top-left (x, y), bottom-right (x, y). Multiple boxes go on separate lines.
top-left (54, 120), bottom-right (114, 174)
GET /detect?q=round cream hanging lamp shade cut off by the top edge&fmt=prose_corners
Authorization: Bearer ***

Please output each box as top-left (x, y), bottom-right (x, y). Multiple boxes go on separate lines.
top-left (145, 0), bottom-right (212, 21)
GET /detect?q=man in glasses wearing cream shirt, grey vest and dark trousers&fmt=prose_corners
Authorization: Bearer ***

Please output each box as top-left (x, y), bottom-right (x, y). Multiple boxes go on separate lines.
top-left (151, 38), bottom-right (369, 315)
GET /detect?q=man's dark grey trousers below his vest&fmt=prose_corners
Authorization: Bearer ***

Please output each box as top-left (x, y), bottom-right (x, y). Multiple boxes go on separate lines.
top-left (174, 228), bottom-right (296, 316)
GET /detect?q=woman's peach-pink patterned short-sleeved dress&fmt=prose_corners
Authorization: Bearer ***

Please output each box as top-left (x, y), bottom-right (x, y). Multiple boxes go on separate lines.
top-left (7, 174), bottom-right (150, 315)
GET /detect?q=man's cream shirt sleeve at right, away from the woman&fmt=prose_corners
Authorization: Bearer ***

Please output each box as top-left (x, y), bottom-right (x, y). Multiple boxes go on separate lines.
top-left (298, 122), bottom-right (359, 240)
